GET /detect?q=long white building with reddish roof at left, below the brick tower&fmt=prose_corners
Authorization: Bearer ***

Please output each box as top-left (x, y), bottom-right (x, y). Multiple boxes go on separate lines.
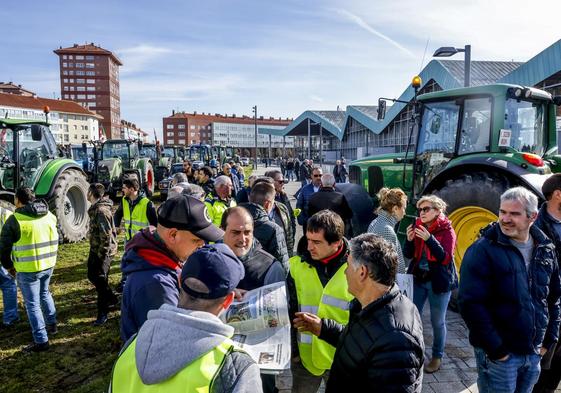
top-left (0, 93), bottom-right (102, 145)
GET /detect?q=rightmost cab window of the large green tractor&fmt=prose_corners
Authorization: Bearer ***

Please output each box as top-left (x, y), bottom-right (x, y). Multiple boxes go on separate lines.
top-left (504, 98), bottom-right (547, 156)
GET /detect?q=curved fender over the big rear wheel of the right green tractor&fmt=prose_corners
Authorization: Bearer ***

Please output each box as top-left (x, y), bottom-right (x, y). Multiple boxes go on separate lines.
top-left (423, 157), bottom-right (551, 200)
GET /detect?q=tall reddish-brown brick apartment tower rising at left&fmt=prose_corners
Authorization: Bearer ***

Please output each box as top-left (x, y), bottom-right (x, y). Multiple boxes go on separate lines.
top-left (54, 43), bottom-right (123, 139)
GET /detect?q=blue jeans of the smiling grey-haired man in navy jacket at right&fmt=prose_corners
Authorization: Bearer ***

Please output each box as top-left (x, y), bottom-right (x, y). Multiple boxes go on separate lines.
top-left (474, 348), bottom-right (541, 393)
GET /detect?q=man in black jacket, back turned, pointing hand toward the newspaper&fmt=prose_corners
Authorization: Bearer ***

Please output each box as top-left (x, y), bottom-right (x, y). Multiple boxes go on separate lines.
top-left (294, 233), bottom-right (425, 393)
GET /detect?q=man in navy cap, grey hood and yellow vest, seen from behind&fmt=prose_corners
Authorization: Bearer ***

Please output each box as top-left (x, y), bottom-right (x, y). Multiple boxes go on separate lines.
top-left (114, 244), bottom-right (262, 393)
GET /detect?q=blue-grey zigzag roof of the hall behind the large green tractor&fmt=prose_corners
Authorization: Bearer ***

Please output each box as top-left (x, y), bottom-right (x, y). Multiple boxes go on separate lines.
top-left (264, 40), bottom-right (561, 140)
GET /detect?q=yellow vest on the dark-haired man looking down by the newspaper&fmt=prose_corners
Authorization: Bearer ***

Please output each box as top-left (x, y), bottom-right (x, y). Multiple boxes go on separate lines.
top-left (289, 256), bottom-right (354, 375)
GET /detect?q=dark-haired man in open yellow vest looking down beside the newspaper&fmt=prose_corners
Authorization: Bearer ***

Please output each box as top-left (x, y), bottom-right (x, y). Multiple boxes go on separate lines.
top-left (287, 210), bottom-right (353, 393)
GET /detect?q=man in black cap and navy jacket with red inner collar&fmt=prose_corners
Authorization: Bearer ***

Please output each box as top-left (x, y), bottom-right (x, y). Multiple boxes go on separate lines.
top-left (121, 196), bottom-right (224, 341)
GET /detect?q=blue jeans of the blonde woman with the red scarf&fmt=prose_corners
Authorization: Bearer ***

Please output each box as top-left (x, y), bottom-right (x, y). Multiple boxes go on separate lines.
top-left (413, 280), bottom-right (452, 359)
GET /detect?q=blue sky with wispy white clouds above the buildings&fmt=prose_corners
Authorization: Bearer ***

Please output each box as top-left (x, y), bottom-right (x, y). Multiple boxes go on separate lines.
top-left (0, 0), bottom-right (561, 139)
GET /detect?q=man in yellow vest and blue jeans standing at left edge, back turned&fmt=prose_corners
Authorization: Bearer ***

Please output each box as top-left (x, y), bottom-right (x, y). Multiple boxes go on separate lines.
top-left (0, 187), bottom-right (58, 352)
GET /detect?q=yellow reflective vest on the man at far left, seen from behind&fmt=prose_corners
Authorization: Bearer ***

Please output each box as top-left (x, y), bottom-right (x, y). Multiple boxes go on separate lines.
top-left (12, 212), bottom-right (58, 273)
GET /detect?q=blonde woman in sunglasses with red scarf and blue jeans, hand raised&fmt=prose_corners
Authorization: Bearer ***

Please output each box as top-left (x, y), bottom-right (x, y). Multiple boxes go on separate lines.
top-left (403, 195), bottom-right (458, 373)
